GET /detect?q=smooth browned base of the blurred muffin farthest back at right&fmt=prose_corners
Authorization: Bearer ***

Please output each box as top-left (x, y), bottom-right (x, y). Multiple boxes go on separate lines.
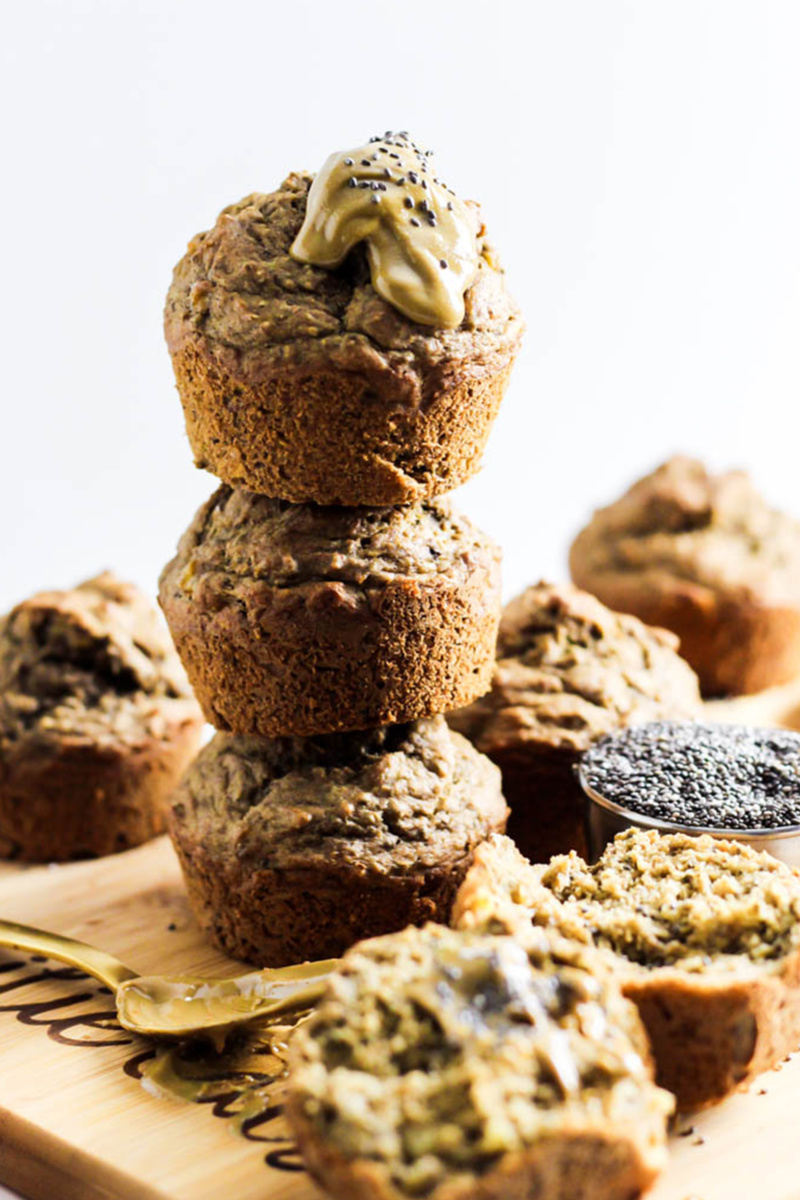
top-left (571, 568), bottom-right (800, 697)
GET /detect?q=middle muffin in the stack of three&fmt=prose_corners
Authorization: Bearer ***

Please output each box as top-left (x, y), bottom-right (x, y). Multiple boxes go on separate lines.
top-left (161, 486), bottom-right (500, 737)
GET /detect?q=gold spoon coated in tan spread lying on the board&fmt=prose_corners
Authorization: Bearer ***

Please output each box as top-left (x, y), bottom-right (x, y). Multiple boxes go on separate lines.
top-left (0, 920), bottom-right (337, 1044)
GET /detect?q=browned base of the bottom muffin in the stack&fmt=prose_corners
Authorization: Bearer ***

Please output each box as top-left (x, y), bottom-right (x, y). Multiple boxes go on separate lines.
top-left (170, 840), bottom-right (489, 967)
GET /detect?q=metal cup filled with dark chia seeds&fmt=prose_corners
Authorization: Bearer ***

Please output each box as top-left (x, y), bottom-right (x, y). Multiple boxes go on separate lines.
top-left (578, 721), bottom-right (800, 866)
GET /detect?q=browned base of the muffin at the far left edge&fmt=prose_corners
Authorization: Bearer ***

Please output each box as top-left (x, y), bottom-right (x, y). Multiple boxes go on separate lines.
top-left (0, 720), bottom-right (200, 863)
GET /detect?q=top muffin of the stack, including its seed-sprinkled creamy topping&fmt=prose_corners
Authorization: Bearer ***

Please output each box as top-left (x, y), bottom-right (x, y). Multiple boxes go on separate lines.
top-left (164, 134), bottom-right (523, 506)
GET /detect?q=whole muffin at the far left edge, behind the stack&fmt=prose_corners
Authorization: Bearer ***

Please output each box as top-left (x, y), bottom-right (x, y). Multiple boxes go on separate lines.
top-left (0, 572), bottom-right (203, 862)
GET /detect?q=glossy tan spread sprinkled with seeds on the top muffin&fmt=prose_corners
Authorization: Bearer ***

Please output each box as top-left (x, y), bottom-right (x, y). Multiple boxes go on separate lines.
top-left (291, 131), bottom-right (483, 329)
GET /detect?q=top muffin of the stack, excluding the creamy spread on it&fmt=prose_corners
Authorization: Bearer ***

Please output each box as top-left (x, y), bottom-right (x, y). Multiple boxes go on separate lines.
top-left (166, 140), bottom-right (523, 505)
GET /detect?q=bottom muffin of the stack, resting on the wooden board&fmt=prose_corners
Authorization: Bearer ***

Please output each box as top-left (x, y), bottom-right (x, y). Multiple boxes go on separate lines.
top-left (170, 716), bottom-right (507, 966)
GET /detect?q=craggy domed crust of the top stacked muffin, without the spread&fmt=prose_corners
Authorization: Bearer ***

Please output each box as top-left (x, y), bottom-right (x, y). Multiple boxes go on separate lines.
top-left (166, 173), bottom-right (522, 404)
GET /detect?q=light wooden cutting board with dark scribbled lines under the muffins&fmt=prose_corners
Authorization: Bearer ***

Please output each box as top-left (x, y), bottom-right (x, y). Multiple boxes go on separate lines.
top-left (0, 688), bottom-right (800, 1200)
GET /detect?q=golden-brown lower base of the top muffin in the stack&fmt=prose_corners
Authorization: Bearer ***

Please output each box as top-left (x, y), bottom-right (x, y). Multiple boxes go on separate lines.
top-left (173, 340), bottom-right (513, 508)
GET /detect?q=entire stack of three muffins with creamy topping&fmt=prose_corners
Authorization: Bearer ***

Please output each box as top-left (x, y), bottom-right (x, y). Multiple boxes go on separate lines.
top-left (161, 133), bottom-right (523, 965)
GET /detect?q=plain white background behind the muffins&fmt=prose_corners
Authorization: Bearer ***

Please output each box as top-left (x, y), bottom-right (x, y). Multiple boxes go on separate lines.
top-left (0, 0), bottom-right (800, 606)
